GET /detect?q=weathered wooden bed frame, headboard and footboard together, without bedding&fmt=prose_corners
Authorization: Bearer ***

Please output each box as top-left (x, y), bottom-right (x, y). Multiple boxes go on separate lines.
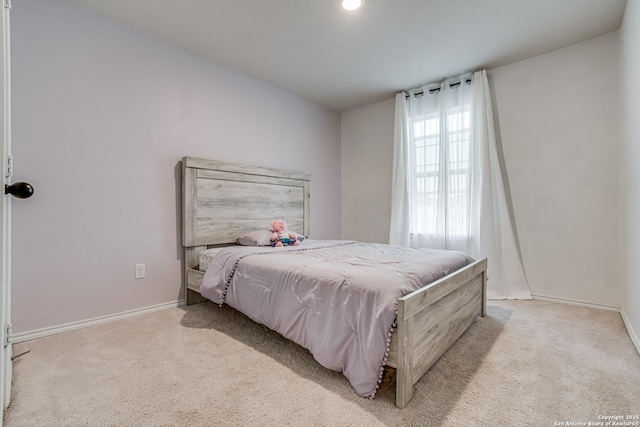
top-left (182, 157), bottom-right (487, 408)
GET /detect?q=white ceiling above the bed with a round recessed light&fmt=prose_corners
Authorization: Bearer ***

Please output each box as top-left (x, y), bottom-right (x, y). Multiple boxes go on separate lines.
top-left (73, 0), bottom-right (626, 111)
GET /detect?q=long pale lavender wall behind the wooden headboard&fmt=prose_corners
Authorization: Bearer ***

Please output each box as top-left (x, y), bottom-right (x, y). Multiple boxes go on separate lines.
top-left (12, 0), bottom-right (341, 333)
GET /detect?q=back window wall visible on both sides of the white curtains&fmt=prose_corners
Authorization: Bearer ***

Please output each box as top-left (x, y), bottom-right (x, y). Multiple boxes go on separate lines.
top-left (342, 32), bottom-right (620, 307)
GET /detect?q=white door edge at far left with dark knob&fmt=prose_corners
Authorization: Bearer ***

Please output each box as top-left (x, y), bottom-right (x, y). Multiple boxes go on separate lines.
top-left (0, 0), bottom-right (12, 418)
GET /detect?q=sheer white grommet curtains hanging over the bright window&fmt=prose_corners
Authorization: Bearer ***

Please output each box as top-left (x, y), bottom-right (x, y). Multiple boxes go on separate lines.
top-left (389, 70), bottom-right (531, 299)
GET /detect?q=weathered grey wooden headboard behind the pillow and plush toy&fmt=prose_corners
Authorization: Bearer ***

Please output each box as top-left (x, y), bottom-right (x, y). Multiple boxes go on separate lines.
top-left (182, 157), bottom-right (311, 262)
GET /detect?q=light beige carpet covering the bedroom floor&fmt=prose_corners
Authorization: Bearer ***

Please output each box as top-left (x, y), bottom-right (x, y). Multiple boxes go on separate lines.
top-left (4, 301), bottom-right (640, 427)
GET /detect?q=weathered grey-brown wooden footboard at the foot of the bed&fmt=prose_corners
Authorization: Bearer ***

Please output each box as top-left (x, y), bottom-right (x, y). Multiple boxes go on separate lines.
top-left (389, 259), bottom-right (487, 408)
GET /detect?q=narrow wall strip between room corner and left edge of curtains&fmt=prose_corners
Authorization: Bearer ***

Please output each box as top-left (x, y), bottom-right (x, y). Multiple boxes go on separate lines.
top-left (342, 99), bottom-right (395, 243)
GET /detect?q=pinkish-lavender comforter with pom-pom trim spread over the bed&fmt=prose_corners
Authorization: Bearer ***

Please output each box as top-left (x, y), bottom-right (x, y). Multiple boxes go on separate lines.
top-left (200, 240), bottom-right (473, 398)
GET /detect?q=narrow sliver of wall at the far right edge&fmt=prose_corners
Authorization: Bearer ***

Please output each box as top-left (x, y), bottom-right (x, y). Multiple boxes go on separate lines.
top-left (620, 0), bottom-right (640, 351)
